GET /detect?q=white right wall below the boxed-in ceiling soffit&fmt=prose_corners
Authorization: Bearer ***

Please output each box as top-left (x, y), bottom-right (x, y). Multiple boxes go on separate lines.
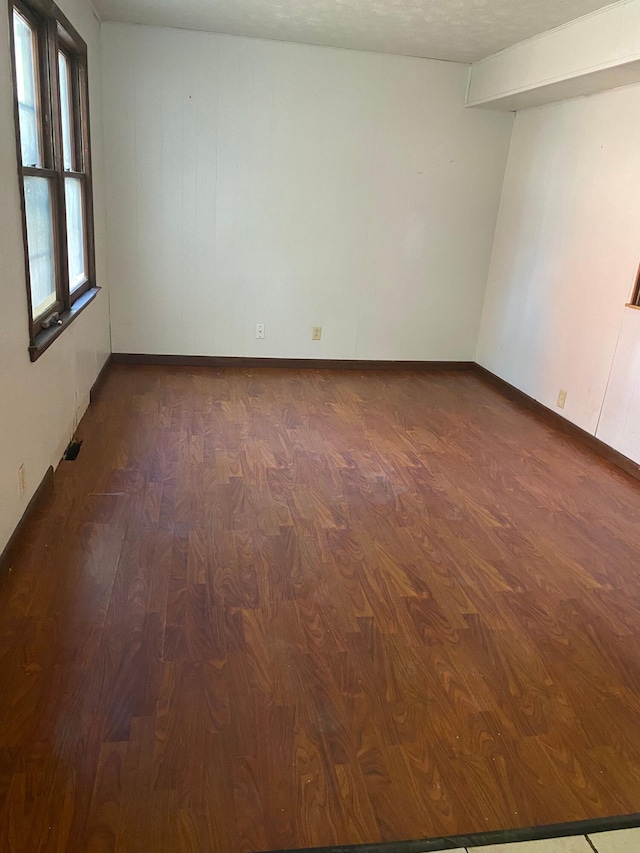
top-left (477, 81), bottom-right (640, 461)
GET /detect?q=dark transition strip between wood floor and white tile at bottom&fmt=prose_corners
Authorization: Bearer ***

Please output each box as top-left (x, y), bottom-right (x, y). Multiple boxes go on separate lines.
top-left (258, 814), bottom-right (640, 853)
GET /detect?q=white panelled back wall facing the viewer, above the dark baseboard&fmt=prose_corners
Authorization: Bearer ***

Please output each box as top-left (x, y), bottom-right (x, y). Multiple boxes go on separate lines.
top-left (103, 24), bottom-right (512, 360)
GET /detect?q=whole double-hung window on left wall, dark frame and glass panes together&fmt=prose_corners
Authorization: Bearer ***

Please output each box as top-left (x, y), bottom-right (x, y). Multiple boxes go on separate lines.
top-left (9, 0), bottom-right (98, 360)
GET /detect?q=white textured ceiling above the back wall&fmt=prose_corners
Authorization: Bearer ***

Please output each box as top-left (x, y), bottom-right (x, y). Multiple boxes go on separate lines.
top-left (94, 0), bottom-right (610, 62)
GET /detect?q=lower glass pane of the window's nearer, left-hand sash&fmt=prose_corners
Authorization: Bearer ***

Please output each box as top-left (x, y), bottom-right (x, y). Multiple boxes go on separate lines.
top-left (24, 178), bottom-right (56, 319)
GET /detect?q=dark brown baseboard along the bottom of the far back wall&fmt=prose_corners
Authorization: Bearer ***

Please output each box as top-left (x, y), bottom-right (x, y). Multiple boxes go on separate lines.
top-left (111, 352), bottom-right (476, 372)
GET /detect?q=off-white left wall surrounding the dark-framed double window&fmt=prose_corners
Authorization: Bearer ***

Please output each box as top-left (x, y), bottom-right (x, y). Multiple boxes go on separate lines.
top-left (0, 0), bottom-right (109, 551)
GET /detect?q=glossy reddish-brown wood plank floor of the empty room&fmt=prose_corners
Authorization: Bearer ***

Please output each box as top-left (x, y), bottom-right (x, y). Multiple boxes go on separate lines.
top-left (0, 365), bottom-right (640, 853)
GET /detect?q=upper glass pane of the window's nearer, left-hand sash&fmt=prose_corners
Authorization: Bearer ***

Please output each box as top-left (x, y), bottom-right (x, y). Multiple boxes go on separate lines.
top-left (13, 10), bottom-right (42, 166)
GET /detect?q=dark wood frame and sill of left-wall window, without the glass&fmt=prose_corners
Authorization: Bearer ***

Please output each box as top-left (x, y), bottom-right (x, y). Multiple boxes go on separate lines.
top-left (8, 0), bottom-right (100, 361)
